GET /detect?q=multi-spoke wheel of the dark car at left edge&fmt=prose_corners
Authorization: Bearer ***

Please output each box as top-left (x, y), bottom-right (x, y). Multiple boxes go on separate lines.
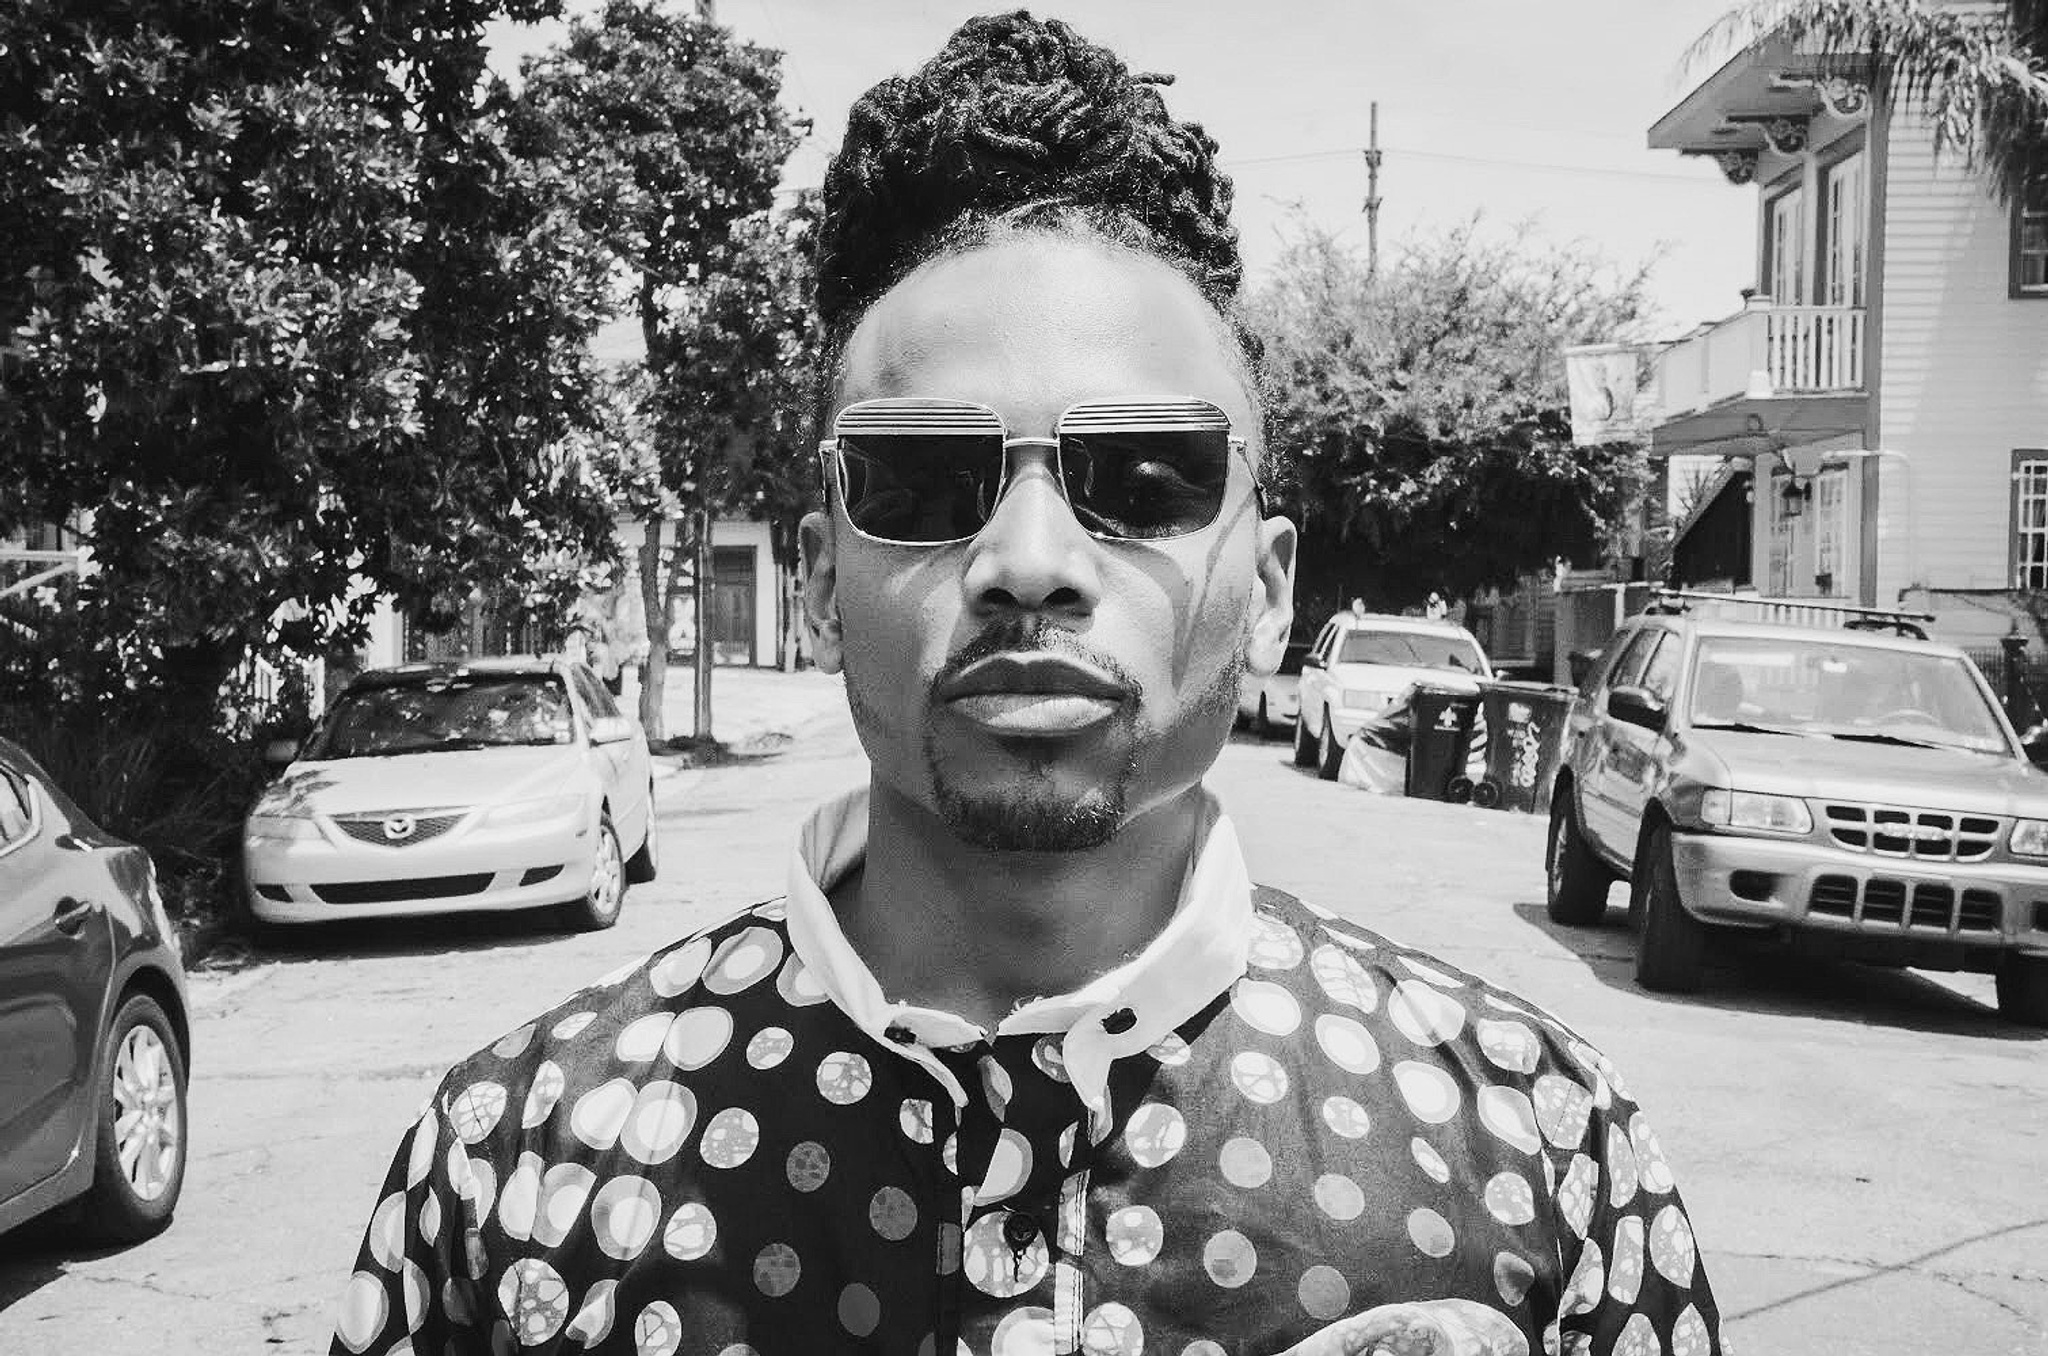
top-left (72, 993), bottom-right (186, 1243)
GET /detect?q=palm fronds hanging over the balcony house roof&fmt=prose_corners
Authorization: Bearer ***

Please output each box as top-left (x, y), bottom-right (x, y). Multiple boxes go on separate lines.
top-left (1686, 0), bottom-right (2048, 197)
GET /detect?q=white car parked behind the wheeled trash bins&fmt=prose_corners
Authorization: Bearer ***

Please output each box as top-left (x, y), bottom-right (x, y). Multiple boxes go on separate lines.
top-left (1294, 612), bottom-right (1493, 780)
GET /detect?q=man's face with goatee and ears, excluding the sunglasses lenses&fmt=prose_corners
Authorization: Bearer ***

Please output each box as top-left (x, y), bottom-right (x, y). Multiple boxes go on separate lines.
top-left (805, 236), bottom-right (1292, 850)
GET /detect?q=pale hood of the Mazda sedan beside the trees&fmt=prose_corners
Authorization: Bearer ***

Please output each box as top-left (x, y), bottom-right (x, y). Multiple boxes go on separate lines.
top-left (254, 744), bottom-right (584, 815)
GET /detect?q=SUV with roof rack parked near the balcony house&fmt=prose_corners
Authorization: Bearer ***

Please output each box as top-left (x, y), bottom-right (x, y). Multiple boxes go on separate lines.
top-left (1548, 615), bottom-right (2048, 1024)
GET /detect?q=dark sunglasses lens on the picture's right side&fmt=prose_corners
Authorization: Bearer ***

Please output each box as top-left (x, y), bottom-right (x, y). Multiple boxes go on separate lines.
top-left (1059, 428), bottom-right (1231, 541)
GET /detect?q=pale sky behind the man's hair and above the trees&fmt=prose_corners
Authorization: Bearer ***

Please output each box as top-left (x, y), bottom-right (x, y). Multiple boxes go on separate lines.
top-left (492, 0), bottom-right (1755, 338)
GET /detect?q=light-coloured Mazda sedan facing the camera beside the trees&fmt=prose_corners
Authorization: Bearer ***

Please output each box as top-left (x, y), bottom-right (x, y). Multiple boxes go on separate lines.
top-left (242, 658), bottom-right (657, 928)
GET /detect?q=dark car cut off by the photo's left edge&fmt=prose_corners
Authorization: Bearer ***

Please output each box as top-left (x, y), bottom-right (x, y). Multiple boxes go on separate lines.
top-left (0, 739), bottom-right (193, 1243)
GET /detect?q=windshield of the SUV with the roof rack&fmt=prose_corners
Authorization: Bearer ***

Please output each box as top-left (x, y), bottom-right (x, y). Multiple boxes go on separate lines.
top-left (1692, 637), bottom-right (2009, 754)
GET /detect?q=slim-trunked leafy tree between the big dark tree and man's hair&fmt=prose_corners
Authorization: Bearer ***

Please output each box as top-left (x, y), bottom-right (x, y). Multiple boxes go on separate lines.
top-left (524, 0), bottom-right (801, 739)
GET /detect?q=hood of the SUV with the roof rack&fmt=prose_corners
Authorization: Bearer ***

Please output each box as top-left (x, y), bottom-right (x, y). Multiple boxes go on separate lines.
top-left (1686, 729), bottom-right (2048, 817)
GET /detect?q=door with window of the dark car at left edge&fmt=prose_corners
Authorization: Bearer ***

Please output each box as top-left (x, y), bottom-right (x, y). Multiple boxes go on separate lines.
top-left (0, 760), bottom-right (113, 1200)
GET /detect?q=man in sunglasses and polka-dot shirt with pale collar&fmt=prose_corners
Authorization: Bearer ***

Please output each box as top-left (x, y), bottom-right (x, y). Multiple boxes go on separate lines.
top-left (336, 14), bottom-right (1718, 1356)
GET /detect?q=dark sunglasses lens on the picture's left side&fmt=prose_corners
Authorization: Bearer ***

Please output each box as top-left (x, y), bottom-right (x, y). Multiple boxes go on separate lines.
top-left (840, 434), bottom-right (1004, 543)
